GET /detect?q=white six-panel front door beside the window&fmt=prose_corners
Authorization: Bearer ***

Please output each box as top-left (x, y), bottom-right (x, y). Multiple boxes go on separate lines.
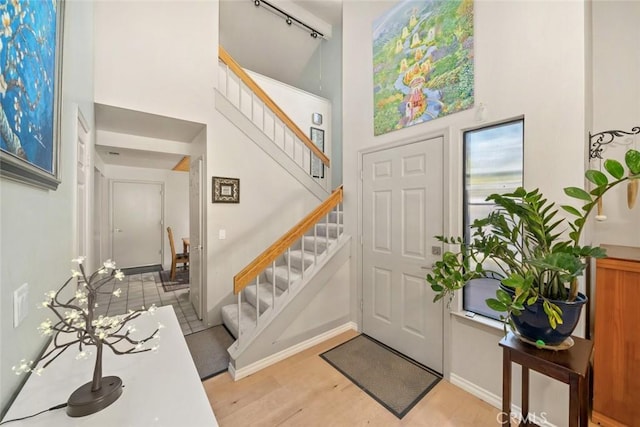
top-left (362, 137), bottom-right (444, 373)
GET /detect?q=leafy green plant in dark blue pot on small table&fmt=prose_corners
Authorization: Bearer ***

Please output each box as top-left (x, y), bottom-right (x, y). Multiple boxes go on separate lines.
top-left (426, 149), bottom-right (640, 346)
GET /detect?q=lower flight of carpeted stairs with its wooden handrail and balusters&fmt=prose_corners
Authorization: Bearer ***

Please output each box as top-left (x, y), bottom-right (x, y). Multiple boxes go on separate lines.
top-left (222, 188), bottom-right (344, 358)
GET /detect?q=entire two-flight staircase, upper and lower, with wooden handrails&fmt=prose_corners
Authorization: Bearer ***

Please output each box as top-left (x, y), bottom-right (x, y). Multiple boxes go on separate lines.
top-left (216, 47), bottom-right (350, 379)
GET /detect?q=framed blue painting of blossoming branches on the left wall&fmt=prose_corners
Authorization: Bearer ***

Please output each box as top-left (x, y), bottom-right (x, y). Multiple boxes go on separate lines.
top-left (0, 0), bottom-right (59, 182)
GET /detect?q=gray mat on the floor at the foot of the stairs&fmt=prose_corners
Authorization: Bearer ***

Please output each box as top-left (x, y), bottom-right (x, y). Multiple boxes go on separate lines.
top-left (184, 325), bottom-right (235, 380)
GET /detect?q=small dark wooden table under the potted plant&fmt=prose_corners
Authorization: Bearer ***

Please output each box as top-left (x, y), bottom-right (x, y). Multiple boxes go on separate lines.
top-left (500, 332), bottom-right (593, 427)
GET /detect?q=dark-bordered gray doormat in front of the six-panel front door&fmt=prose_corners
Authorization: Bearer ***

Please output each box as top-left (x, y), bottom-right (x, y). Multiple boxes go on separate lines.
top-left (320, 335), bottom-right (441, 418)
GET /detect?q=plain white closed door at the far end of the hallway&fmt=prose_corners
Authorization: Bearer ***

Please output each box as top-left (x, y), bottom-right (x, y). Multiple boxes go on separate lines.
top-left (111, 181), bottom-right (164, 267)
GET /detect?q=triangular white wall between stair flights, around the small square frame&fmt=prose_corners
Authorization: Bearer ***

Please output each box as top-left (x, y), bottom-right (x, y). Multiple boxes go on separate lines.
top-left (207, 113), bottom-right (330, 324)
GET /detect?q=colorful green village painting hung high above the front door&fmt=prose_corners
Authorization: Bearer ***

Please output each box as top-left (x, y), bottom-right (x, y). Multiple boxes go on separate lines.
top-left (373, 0), bottom-right (473, 135)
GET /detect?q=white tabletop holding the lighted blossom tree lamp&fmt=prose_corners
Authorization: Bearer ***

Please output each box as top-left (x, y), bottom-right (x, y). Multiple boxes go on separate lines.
top-left (3, 306), bottom-right (218, 427)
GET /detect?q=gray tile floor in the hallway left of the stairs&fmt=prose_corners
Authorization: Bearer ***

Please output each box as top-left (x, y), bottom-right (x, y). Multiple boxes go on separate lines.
top-left (96, 272), bottom-right (207, 335)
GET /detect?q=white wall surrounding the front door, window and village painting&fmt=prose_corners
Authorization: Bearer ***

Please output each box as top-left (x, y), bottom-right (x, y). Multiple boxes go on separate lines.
top-left (343, 0), bottom-right (587, 425)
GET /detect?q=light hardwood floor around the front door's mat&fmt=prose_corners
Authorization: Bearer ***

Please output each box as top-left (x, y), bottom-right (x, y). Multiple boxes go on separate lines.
top-left (203, 331), bottom-right (596, 427)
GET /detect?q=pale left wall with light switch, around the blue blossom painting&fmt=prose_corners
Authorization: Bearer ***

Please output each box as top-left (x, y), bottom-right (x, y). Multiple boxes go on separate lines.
top-left (0, 1), bottom-right (94, 416)
